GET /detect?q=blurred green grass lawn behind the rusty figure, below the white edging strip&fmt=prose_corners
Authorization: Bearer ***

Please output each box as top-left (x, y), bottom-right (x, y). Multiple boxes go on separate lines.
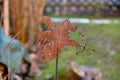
top-left (36, 21), bottom-right (120, 80)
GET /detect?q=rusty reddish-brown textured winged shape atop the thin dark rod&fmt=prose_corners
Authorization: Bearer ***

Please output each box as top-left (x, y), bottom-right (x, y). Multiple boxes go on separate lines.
top-left (36, 17), bottom-right (79, 62)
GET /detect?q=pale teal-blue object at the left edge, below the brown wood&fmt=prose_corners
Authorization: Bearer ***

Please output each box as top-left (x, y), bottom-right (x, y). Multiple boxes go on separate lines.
top-left (0, 27), bottom-right (30, 75)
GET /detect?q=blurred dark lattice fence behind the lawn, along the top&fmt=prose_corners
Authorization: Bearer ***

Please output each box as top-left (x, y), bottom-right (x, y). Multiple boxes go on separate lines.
top-left (44, 0), bottom-right (120, 17)
